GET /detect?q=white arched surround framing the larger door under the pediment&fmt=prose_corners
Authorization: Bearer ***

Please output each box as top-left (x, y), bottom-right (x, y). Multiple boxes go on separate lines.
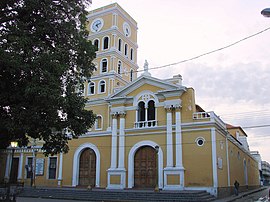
top-left (128, 140), bottom-right (163, 189)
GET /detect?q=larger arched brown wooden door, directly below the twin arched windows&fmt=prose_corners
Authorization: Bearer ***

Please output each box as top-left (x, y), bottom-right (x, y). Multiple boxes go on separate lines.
top-left (134, 146), bottom-right (157, 188)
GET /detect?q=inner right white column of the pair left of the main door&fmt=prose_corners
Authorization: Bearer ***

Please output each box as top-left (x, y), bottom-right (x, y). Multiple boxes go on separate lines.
top-left (118, 113), bottom-right (126, 168)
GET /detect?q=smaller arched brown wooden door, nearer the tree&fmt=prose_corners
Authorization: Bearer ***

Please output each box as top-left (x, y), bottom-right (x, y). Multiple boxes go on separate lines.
top-left (79, 148), bottom-right (96, 187)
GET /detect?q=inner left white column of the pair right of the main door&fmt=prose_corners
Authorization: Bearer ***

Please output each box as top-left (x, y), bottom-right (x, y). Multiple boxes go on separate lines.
top-left (167, 108), bottom-right (173, 167)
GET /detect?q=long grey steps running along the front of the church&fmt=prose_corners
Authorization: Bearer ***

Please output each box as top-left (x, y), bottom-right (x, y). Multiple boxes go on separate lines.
top-left (18, 187), bottom-right (215, 202)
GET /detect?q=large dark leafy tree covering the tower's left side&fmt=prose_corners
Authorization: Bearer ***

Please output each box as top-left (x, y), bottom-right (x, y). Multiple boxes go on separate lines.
top-left (0, 0), bottom-right (95, 155)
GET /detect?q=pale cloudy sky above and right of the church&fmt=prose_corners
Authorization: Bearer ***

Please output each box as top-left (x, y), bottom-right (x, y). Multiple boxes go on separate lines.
top-left (90, 0), bottom-right (270, 162)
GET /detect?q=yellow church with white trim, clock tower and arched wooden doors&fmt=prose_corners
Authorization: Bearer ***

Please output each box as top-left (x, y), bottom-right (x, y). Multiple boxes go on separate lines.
top-left (0, 3), bottom-right (260, 196)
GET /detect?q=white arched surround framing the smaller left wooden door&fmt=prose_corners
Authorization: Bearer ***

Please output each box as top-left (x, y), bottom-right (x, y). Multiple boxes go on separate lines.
top-left (72, 142), bottom-right (100, 187)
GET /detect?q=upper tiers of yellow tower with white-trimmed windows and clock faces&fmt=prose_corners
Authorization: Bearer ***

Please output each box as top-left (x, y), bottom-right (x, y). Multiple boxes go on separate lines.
top-left (84, 3), bottom-right (138, 100)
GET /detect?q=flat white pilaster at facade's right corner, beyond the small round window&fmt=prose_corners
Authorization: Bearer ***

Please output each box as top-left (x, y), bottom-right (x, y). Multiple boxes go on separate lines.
top-left (211, 128), bottom-right (218, 188)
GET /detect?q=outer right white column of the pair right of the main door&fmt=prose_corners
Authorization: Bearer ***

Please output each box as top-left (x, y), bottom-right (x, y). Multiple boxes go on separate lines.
top-left (175, 107), bottom-right (183, 167)
